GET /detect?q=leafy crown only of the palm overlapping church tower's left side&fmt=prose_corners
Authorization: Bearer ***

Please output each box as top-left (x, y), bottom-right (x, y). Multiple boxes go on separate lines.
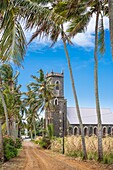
top-left (29, 69), bottom-right (54, 112)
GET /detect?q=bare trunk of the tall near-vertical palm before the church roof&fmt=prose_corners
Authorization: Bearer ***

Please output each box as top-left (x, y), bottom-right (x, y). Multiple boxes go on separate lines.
top-left (94, 11), bottom-right (103, 161)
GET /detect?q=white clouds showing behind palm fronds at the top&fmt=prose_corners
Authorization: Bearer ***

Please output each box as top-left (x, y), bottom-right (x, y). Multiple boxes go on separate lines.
top-left (25, 14), bottom-right (109, 51)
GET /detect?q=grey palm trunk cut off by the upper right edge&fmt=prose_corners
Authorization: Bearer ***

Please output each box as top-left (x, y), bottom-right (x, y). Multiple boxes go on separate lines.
top-left (108, 0), bottom-right (113, 58)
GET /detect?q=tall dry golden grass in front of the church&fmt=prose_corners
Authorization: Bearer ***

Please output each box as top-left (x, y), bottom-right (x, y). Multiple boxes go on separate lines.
top-left (51, 136), bottom-right (113, 164)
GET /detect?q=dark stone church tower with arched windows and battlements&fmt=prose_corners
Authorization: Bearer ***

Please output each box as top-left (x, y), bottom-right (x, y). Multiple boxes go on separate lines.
top-left (45, 72), bottom-right (67, 137)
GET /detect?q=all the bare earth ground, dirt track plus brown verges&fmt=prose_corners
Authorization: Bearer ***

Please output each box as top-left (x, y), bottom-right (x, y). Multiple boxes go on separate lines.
top-left (0, 142), bottom-right (113, 170)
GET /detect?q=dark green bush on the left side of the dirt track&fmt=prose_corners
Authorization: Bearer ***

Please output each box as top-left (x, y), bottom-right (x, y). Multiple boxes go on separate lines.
top-left (3, 136), bottom-right (18, 161)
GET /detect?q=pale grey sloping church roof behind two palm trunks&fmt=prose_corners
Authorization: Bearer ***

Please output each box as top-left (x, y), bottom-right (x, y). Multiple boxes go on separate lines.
top-left (67, 107), bottom-right (113, 125)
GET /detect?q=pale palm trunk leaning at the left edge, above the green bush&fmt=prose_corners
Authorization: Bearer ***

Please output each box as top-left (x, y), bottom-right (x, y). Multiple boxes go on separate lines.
top-left (0, 90), bottom-right (10, 135)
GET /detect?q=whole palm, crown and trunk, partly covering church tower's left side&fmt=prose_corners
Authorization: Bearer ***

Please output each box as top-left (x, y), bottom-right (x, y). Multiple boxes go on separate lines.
top-left (24, 70), bottom-right (54, 137)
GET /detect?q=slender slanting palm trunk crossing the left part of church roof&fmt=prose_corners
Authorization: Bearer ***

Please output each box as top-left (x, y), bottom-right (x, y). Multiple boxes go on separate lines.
top-left (62, 26), bottom-right (87, 159)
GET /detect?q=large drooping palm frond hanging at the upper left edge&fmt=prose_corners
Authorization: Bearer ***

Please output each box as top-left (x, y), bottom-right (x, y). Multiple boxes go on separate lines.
top-left (0, 9), bottom-right (26, 66)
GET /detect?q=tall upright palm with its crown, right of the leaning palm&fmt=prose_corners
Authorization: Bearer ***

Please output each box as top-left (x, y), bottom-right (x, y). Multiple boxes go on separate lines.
top-left (63, 1), bottom-right (106, 161)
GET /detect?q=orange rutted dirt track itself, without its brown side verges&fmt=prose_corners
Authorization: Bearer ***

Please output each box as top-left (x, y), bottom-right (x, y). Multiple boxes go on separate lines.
top-left (23, 142), bottom-right (89, 170)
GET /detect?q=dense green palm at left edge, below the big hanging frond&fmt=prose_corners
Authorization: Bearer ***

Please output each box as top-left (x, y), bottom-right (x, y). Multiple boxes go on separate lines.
top-left (0, 64), bottom-right (21, 136)
